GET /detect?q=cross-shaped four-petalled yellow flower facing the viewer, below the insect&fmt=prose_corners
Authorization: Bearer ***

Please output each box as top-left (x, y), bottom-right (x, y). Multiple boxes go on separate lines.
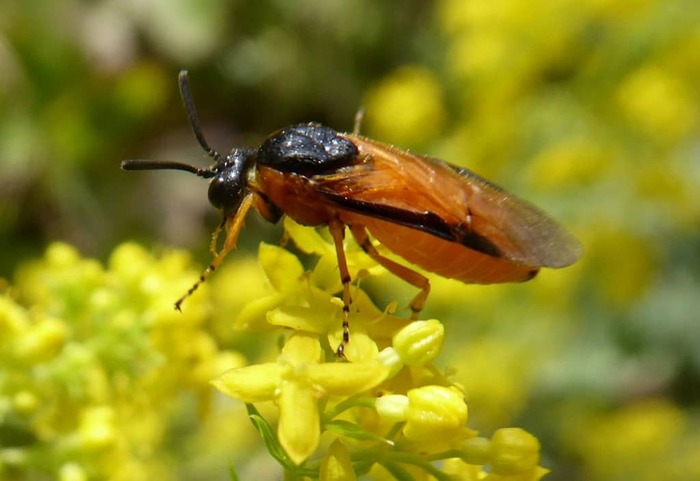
top-left (213, 331), bottom-right (388, 464)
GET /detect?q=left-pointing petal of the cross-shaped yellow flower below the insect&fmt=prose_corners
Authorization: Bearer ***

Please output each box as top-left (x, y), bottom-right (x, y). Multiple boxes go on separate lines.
top-left (211, 363), bottom-right (282, 403)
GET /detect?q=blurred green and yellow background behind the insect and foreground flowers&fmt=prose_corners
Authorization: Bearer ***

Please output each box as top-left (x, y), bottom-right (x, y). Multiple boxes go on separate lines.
top-left (0, 0), bottom-right (700, 480)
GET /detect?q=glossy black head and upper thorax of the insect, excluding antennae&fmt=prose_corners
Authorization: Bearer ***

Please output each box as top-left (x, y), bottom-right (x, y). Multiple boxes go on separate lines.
top-left (204, 124), bottom-right (358, 216)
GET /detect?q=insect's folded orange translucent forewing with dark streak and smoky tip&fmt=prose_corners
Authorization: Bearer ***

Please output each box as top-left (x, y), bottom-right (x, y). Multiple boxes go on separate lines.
top-left (313, 135), bottom-right (581, 267)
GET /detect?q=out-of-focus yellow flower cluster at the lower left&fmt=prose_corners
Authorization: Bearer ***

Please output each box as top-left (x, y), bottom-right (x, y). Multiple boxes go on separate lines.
top-left (0, 243), bottom-right (243, 481)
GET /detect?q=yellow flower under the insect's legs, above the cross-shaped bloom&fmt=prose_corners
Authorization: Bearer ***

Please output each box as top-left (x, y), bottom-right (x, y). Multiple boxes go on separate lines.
top-left (234, 220), bottom-right (409, 362)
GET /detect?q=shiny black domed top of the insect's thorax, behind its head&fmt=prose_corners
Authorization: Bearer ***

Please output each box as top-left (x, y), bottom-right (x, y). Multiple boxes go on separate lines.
top-left (257, 124), bottom-right (358, 175)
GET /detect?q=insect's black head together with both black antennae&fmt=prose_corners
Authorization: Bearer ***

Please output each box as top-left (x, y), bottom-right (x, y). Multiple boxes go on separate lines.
top-left (121, 70), bottom-right (257, 216)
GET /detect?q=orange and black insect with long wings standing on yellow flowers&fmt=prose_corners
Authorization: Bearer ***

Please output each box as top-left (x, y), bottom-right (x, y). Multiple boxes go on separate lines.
top-left (121, 71), bottom-right (582, 355)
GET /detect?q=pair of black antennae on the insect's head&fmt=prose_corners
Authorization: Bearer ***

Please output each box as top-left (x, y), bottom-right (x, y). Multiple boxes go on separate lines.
top-left (121, 70), bottom-right (221, 179)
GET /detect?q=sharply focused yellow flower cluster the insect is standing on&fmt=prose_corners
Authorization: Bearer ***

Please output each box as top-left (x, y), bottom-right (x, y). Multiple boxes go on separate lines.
top-left (213, 219), bottom-right (547, 480)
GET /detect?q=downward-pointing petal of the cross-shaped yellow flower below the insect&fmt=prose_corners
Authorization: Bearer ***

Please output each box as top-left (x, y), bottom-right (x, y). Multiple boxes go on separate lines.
top-left (277, 380), bottom-right (321, 464)
